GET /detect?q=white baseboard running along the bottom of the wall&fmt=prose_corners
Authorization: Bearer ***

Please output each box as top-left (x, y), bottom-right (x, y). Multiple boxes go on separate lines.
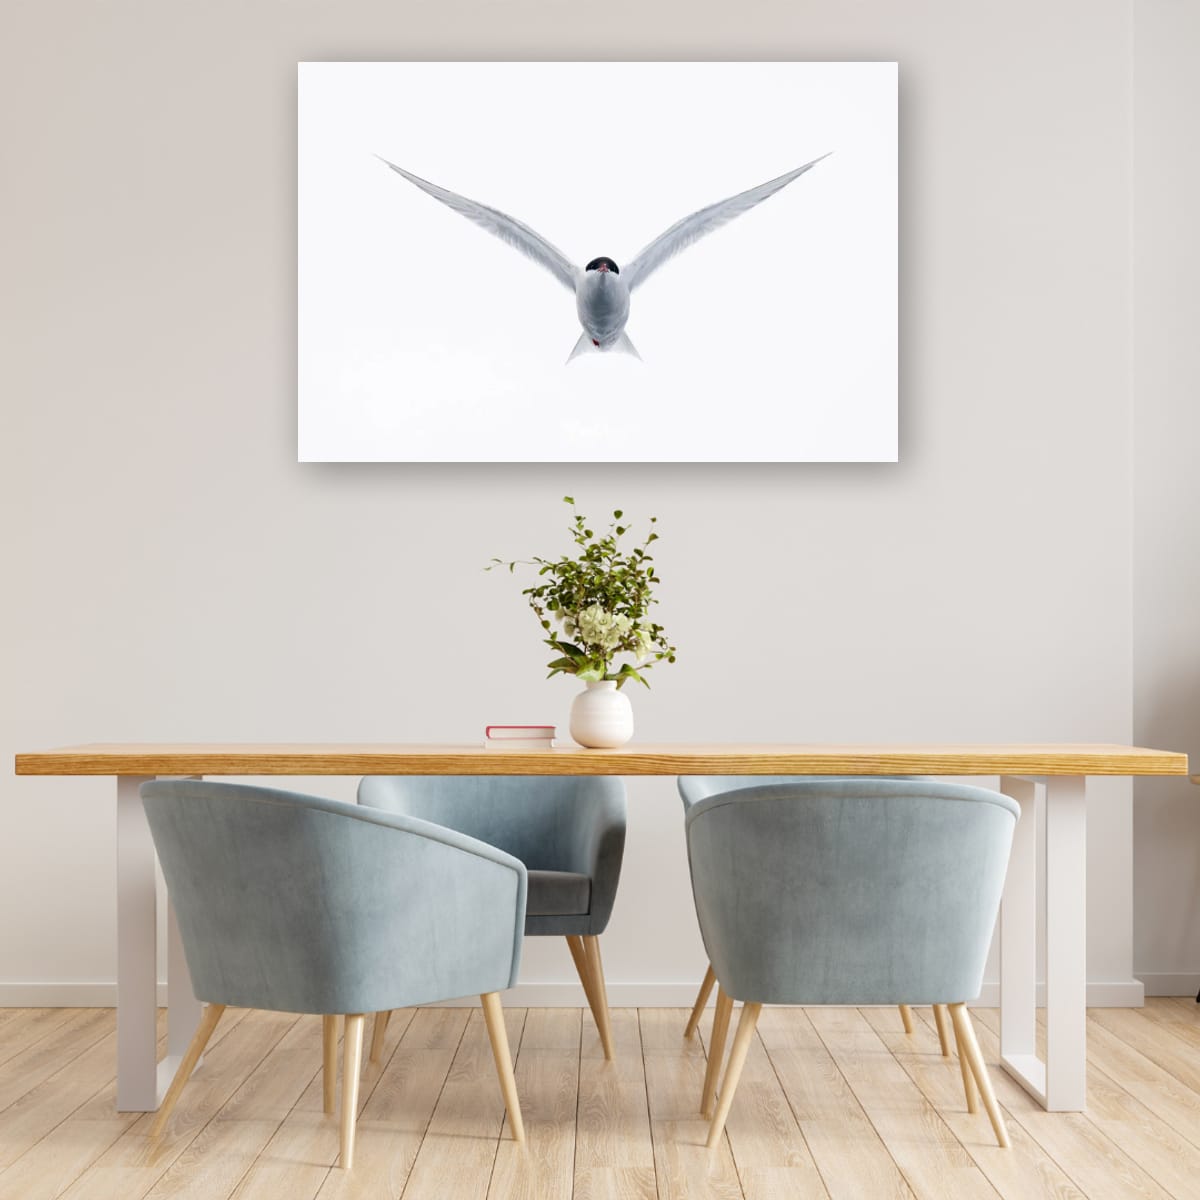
top-left (0, 974), bottom-right (1152, 1008)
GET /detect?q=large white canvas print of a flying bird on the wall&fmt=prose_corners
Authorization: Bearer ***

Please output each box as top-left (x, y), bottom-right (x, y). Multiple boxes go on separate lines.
top-left (299, 62), bottom-right (898, 462)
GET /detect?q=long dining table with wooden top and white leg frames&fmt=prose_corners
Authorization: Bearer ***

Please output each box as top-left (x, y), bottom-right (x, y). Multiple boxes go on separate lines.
top-left (16, 743), bottom-right (1188, 1111)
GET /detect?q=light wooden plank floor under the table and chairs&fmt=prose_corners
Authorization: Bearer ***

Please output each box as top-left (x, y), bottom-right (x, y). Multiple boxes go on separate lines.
top-left (0, 998), bottom-right (1200, 1200)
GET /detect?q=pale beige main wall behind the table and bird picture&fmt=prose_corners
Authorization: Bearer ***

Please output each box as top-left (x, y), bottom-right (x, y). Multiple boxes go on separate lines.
top-left (0, 0), bottom-right (1138, 1002)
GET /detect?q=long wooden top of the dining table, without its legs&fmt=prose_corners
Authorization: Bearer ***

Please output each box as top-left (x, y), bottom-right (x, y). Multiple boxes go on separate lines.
top-left (16, 742), bottom-right (1188, 775)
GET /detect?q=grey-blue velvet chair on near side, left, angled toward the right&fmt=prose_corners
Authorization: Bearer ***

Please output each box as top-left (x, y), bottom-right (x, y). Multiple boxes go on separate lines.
top-left (142, 780), bottom-right (526, 1168)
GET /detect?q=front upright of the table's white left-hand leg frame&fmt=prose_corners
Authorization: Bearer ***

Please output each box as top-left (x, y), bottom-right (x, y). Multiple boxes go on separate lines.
top-left (116, 775), bottom-right (158, 1112)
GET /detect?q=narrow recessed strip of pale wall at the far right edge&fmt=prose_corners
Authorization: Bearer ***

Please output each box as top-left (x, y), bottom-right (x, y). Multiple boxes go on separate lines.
top-left (1133, 0), bottom-right (1200, 995)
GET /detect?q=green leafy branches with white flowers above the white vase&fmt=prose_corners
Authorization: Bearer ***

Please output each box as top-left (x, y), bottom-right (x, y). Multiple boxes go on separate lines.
top-left (487, 496), bottom-right (676, 688)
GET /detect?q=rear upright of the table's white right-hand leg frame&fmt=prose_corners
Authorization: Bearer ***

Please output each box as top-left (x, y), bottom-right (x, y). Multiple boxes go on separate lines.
top-left (1000, 776), bottom-right (1045, 1104)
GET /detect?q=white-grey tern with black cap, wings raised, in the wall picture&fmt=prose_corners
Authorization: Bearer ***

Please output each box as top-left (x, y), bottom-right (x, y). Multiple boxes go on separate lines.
top-left (377, 155), bottom-right (828, 362)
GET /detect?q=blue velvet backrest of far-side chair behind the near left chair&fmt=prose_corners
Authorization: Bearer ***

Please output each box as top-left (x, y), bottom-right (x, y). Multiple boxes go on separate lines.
top-left (359, 772), bottom-right (625, 871)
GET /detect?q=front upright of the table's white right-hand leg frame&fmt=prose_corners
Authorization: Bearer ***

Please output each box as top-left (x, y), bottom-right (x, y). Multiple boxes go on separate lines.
top-left (1045, 776), bottom-right (1087, 1112)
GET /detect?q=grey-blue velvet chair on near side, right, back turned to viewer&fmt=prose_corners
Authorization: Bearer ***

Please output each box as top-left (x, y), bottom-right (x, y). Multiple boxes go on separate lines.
top-left (685, 779), bottom-right (1019, 1147)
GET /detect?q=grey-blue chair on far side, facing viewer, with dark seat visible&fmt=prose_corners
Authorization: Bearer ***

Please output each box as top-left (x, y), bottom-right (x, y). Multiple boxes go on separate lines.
top-left (359, 768), bottom-right (625, 1060)
